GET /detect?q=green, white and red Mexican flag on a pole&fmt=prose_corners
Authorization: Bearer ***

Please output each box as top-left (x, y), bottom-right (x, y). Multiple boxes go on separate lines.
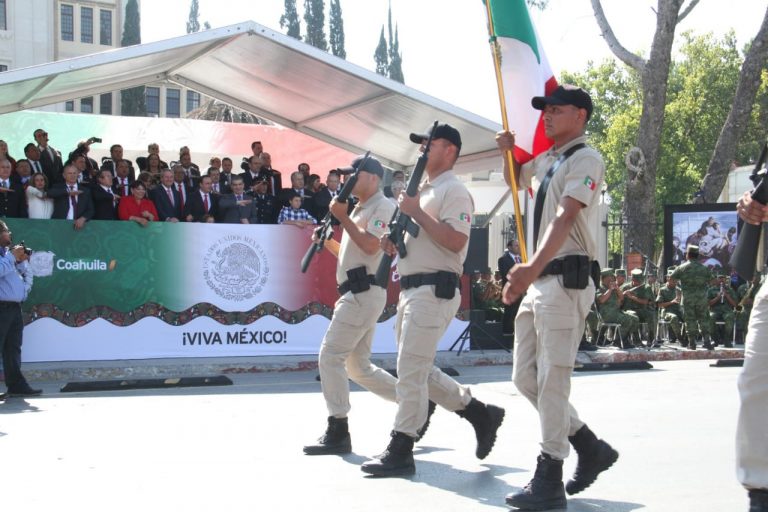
top-left (485, 0), bottom-right (557, 164)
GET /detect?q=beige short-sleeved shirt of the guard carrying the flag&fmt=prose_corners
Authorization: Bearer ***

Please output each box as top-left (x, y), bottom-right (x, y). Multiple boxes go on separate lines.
top-left (521, 136), bottom-right (605, 259)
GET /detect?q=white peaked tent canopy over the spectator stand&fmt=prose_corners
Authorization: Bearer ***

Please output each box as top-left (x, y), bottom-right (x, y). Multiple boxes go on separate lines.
top-left (0, 21), bottom-right (500, 172)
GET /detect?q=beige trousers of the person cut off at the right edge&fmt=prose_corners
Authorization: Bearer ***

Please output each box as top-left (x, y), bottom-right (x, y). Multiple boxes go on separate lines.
top-left (736, 285), bottom-right (768, 489)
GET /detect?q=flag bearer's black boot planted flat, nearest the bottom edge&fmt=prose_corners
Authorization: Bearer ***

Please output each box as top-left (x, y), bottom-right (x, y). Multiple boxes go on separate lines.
top-left (506, 453), bottom-right (568, 510)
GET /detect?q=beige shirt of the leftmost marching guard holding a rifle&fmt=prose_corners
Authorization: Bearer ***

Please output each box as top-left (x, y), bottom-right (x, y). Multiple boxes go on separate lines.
top-left (336, 191), bottom-right (395, 284)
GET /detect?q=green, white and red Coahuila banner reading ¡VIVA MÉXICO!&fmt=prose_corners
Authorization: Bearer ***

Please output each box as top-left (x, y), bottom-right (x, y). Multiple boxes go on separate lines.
top-left (6, 219), bottom-right (468, 362)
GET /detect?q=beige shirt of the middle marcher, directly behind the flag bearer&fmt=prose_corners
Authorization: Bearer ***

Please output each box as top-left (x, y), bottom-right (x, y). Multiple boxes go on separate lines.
top-left (397, 171), bottom-right (474, 276)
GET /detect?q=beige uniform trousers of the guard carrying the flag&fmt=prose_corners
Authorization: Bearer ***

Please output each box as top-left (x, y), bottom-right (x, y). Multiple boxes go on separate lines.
top-left (512, 276), bottom-right (595, 460)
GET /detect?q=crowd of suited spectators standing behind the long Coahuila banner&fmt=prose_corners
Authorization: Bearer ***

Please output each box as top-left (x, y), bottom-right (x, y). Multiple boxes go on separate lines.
top-left (0, 129), bottom-right (396, 229)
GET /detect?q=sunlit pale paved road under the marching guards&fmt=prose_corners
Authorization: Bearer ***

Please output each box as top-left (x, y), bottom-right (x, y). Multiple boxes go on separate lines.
top-left (0, 361), bottom-right (747, 512)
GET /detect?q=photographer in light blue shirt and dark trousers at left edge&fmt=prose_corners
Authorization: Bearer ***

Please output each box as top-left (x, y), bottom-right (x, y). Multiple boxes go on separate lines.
top-left (0, 221), bottom-right (42, 396)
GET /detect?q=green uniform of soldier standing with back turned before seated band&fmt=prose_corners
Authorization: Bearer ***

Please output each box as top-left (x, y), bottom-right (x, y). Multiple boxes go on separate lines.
top-left (671, 256), bottom-right (712, 348)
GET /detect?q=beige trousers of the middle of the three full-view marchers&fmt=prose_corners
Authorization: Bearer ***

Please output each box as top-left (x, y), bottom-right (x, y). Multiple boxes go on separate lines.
top-left (394, 285), bottom-right (472, 437)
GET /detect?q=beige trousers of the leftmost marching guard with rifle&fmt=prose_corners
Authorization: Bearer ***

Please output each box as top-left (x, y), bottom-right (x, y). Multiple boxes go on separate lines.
top-left (319, 286), bottom-right (396, 418)
